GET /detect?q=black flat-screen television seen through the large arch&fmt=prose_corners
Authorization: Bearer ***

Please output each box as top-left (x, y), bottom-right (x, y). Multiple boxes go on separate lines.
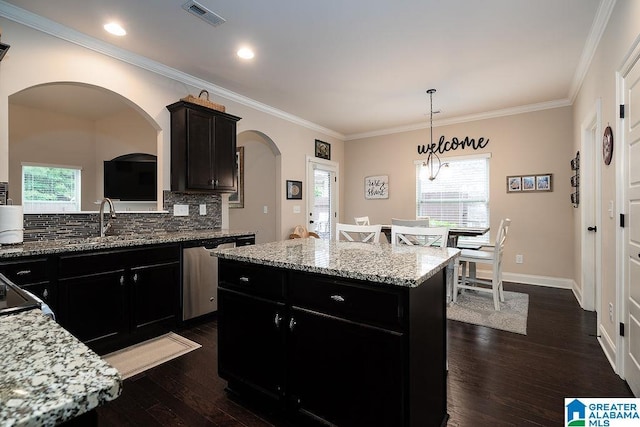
top-left (104, 156), bottom-right (158, 201)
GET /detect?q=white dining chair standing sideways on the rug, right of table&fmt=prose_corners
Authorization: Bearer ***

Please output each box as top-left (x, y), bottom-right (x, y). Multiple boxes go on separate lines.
top-left (453, 218), bottom-right (511, 311)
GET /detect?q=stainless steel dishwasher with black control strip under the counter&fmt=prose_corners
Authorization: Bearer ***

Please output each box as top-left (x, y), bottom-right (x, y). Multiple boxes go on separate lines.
top-left (182, 236), bottom-right (255, 320)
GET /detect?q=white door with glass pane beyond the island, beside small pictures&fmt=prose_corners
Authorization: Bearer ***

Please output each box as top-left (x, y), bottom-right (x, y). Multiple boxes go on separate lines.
top-left (307, 157), bottom-right (338, 240)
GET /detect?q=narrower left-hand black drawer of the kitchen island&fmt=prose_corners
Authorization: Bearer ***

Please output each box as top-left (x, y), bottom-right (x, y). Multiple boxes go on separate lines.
top-left (218, 259), bottom-right (285, 301)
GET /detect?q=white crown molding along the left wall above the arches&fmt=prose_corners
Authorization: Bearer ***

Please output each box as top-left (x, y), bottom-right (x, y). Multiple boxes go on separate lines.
top-left (0, 0), bottom-right (344, 140)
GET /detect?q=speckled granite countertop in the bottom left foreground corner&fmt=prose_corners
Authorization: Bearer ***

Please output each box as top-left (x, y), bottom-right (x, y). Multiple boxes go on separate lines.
top-left (0, 309), bottom-right (122, 426)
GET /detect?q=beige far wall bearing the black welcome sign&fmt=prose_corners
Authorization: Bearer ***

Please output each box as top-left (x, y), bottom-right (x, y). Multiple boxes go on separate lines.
top-left (342, 107), bottom-right (575, 280)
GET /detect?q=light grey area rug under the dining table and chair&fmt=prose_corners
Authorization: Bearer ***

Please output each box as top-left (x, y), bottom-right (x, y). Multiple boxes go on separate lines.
top-left (447, 290), bottom-right (529, 335)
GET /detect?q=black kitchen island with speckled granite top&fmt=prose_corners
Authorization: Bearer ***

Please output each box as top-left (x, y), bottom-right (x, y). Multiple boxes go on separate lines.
top-left (214, 238), bottom-right (459, 427)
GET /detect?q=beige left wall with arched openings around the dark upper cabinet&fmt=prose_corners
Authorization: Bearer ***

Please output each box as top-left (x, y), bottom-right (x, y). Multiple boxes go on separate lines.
top-left (0, 18), bottom-right (344, 239)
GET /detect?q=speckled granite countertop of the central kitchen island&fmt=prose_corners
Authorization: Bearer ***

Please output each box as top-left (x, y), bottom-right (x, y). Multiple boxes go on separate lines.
top-left (212, 238), bottom-right (460, 287)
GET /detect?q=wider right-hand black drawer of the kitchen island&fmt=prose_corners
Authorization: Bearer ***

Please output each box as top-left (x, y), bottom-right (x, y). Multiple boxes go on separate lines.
top-left (289, 273), bottom-right (404, 330)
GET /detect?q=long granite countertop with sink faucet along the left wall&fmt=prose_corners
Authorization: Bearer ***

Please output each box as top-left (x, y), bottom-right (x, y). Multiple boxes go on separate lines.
top-left (0, 229), bottom-right (255, 259)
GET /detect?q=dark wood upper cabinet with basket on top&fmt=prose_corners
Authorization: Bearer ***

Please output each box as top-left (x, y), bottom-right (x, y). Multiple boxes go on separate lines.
top-left (167, 101), bottom-right (240, 193)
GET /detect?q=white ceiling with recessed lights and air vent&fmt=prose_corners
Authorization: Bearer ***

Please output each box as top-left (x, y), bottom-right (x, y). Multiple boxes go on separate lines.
top-left (0, 0), bottom-right (611, 139)
